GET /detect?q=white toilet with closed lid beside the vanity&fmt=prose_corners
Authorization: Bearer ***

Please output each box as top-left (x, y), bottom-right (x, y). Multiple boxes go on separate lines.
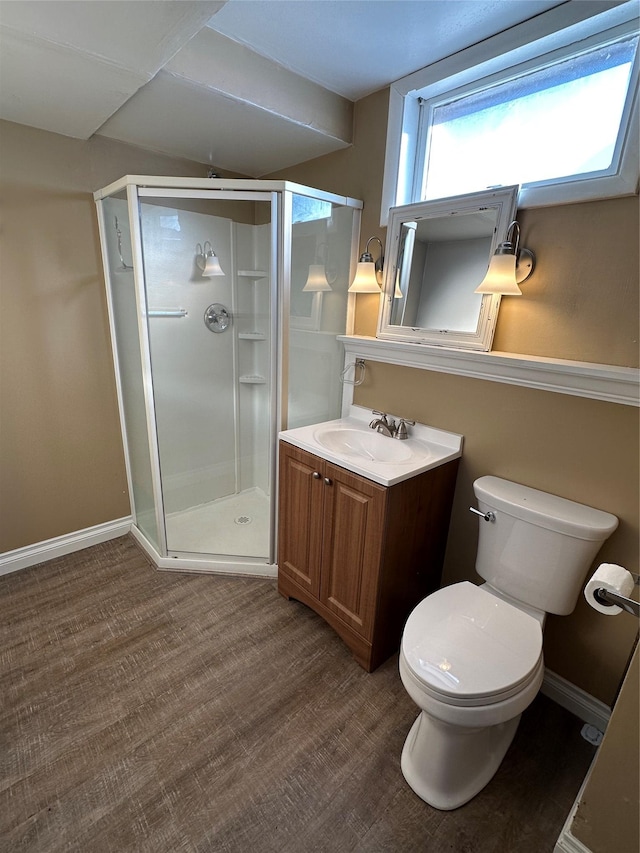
top-left (400, 476), bottom-right (618, 810)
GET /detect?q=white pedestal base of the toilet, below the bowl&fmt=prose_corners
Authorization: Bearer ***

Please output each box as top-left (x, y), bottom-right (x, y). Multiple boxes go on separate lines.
top-left (400, 711), bottom-right (521, 811)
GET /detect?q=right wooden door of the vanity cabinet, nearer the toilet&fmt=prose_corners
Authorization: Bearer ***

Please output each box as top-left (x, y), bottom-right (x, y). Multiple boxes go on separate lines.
top-left (320, 463), bottom-right (387, 639)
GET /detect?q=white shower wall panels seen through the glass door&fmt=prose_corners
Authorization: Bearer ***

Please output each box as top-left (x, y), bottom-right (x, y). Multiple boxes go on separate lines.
top-left (141, 203), bottom-right (269, 514)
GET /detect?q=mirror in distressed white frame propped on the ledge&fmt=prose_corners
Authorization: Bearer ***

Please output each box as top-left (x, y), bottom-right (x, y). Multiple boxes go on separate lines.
top-left (377, 186), bottom-right (518, 351)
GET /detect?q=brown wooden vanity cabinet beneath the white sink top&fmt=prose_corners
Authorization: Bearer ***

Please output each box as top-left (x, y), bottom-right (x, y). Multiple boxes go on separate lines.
top-left (278, 439), bottom-right (458, 672)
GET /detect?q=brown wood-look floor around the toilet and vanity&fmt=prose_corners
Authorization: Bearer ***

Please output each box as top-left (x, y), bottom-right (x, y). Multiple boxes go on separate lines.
top-left (0, 537), bottom-right (594, 853)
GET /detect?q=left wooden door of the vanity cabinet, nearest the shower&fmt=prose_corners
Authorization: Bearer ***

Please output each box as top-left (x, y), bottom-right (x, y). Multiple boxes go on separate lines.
top-left (278, 442), bottom-right (325, 598)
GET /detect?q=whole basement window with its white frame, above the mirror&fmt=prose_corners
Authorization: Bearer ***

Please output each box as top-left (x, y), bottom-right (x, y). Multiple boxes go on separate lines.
top-left (383, 4), bottom-right (639, 218)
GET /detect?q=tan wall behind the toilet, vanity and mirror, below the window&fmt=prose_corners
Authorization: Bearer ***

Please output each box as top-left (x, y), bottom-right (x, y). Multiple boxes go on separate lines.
top-left (278, 91), bottom-right (639, 704)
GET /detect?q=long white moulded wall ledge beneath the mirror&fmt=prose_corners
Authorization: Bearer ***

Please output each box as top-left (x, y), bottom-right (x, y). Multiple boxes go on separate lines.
top-left (338, 335), bottom-right (640, 406)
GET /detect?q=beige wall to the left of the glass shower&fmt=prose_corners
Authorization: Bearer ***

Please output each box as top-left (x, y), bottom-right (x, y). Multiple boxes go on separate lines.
top-left (0, 122), bottom-right (238, 552)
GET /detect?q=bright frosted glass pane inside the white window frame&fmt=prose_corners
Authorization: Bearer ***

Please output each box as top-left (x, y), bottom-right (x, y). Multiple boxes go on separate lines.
top-left (420, 36), bottom-right (638, 200)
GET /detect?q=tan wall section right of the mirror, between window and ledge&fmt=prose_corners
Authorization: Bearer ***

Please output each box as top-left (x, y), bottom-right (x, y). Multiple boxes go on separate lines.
top-left (493, 196), bottom-right (640, 367)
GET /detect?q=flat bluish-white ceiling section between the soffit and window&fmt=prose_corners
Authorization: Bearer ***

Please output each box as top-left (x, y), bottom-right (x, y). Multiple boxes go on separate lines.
top-left (209, 0), bottom-right (564, 101)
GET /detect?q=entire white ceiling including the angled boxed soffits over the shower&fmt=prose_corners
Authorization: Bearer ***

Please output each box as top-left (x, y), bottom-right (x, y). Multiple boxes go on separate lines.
top-left (0, 0), bottom-right (592, 177)
